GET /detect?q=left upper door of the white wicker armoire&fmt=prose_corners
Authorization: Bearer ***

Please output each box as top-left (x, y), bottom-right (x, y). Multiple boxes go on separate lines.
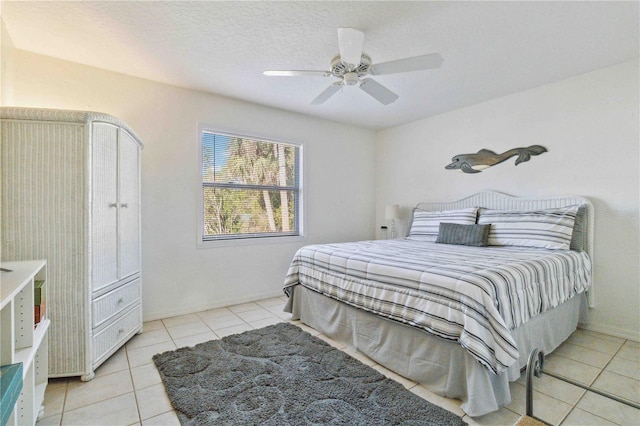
top-left (90, 122), bottom-right (119, 291)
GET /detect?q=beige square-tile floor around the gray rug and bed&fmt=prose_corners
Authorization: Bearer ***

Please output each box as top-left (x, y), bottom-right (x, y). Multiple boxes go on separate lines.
top-left (38, 297), bottom-right (640, 426)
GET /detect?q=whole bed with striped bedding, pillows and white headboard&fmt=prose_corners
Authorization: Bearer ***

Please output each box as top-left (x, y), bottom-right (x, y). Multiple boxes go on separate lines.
top-left (284, 191), bottom-right (593, 416)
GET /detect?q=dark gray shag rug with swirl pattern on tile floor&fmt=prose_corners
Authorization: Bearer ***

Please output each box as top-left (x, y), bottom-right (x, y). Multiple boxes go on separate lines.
top-left (153, 323), bottom-right (465, 426)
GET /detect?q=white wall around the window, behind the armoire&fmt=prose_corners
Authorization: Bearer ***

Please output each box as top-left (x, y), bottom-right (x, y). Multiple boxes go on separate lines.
top-left (6, 50), bottom-right (375, 320)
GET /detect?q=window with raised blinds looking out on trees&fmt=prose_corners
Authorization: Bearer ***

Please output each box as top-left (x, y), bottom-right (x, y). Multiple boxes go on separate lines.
top-left (200, 130), bottom-right (302, 241)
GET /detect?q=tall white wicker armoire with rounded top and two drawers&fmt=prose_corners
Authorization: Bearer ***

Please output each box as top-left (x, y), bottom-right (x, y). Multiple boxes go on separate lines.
top-left (0, 107), bottom-right (142, 380)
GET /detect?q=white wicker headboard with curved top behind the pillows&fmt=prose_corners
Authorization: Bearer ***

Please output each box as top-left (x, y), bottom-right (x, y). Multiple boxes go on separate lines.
top-left (416, 191), bottom-right (594, 307)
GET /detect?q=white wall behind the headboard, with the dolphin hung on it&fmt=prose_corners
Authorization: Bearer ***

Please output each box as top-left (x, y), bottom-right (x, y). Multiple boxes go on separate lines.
top-left (376, 60), bottom-right (640, 340)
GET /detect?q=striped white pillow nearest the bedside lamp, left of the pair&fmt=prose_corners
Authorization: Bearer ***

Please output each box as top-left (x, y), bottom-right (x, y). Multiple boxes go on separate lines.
top-left (407, 207), bottom-right (478, 241)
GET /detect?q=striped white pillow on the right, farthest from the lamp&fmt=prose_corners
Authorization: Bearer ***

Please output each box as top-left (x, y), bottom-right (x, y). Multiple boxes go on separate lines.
top-left (478, 206), bottom-right (578, 250)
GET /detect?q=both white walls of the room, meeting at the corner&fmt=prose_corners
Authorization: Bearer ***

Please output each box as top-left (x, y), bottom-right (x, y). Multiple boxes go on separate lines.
top-left (2, 39), bottom-right (640, 340)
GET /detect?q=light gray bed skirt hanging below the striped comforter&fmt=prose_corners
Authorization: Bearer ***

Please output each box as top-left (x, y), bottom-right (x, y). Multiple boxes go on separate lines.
top-left (285, 285), bottom-right (588, 416)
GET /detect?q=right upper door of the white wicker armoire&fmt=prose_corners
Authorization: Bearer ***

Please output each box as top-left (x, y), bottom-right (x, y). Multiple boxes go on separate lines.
top-left (118, 129), bottom-right (140, 279)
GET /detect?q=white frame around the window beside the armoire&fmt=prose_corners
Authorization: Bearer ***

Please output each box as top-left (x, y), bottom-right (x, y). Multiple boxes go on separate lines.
top-left (197, 123), bottom-right (306, 248)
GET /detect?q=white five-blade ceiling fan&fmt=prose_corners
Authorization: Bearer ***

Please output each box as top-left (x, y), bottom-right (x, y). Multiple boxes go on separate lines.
top-left (263, 28), bottom-right (443, 105)
